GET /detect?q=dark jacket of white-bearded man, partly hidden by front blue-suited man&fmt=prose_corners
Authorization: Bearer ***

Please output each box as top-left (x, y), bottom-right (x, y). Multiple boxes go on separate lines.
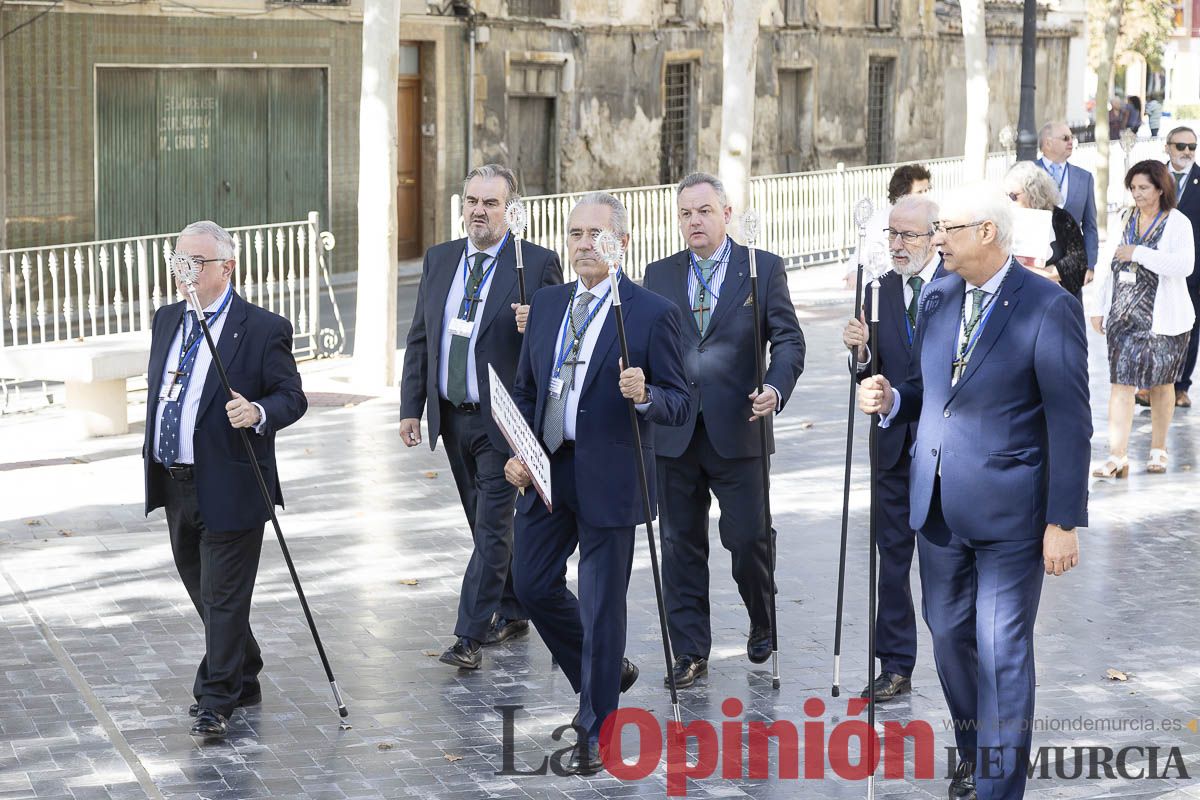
top-left (862, 263), bottom-right (946, 469)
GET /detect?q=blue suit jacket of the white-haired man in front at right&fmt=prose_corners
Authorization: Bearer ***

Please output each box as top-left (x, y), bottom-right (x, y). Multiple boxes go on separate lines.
top-left (893, 261), bottom-right (1092, 540)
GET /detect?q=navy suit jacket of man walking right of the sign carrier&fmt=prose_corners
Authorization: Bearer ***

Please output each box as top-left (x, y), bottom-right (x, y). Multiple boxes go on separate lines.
top-left (642, 243), bottom-right (804, 458)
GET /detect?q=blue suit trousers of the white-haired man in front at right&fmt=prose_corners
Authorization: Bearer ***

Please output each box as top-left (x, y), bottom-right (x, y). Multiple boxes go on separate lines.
top-left (917, 482), bottom-right (1045, 800)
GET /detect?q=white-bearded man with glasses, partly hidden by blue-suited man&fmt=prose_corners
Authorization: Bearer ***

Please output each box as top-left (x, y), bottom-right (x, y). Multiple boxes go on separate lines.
top-left (842, 194), bottom-right (946, 703)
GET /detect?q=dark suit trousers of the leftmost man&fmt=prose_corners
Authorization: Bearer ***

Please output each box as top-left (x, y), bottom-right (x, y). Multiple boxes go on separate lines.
top-left (162, 465), bottom-right (263, 717)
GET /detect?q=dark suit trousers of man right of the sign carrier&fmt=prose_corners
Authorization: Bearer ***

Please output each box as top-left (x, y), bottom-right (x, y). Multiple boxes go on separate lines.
top-left (656, 416), bottom-right (775, 658)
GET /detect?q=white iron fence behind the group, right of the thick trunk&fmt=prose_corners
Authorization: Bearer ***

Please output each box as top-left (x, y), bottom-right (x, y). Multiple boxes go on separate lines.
top-left (450, 139), bottom-right (1163, 279)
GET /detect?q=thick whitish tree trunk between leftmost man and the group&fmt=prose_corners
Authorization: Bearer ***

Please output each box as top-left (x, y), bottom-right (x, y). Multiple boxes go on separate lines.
top-left (354, 0), bottom-right (400, 386)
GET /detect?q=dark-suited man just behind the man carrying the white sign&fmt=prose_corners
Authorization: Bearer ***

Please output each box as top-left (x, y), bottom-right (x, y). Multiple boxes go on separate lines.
top-left (400, 164), bottom-right (563, 669)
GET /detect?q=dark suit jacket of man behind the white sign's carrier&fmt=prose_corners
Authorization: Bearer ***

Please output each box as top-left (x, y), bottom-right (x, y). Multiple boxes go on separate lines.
top-left (400, 237), bottom-right (563, 452)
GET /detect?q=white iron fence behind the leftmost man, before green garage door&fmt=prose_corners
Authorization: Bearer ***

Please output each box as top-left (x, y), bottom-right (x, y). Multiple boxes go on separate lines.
top-left (0, 212), bottom-right (346, 357)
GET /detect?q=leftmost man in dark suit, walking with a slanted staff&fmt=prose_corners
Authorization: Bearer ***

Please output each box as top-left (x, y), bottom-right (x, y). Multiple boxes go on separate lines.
top-left (142, 221), bottom-right (308, 739)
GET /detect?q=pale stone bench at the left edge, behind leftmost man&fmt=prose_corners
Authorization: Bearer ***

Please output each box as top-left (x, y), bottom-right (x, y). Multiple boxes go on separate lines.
top-left (0, 331), bottom-right (150, 437)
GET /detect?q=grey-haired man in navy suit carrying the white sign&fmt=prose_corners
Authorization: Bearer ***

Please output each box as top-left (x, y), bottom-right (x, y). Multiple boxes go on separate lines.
top-left (505, 192), bottom-right (688, 774)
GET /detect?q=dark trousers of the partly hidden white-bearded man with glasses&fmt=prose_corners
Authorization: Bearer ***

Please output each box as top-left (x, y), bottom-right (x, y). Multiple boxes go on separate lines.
top-left (875, 451), bottom-right (917, 678)
